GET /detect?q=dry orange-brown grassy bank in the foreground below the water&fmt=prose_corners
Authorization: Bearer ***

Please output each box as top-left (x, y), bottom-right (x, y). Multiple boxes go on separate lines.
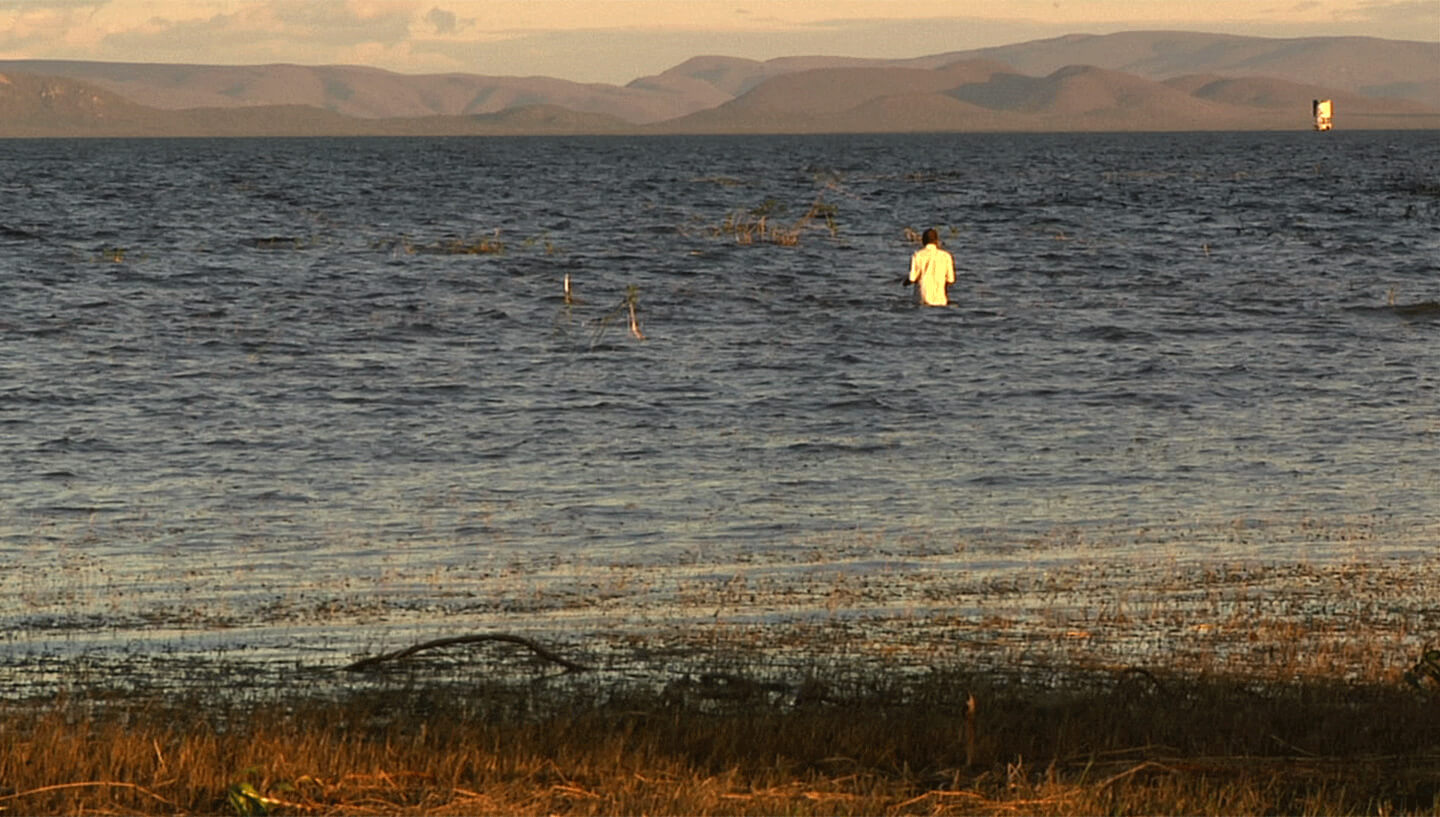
top-left (0, 667), bottom-right (1440, 814)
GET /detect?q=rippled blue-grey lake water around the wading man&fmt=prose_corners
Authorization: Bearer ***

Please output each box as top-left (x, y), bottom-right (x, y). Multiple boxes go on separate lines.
top-left (0, 133), bottom-right (1440, 691)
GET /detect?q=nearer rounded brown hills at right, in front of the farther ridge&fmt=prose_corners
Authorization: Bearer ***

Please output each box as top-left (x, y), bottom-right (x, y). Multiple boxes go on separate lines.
top-left (661, 61), bottom-right (1440, 133)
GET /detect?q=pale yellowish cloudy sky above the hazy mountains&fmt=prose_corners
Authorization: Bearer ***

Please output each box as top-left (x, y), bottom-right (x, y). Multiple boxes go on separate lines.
top-left (0, 0), bottom-right (1440, 84)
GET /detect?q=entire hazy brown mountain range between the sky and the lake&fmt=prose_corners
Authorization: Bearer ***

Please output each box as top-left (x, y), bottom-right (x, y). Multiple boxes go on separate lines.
top-left (0, 32), bottom-right (1440, 137)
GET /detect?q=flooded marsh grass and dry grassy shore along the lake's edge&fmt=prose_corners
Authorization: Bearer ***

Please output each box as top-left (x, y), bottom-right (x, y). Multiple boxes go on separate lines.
top-left (0, 536), bottom-right (1440, 814)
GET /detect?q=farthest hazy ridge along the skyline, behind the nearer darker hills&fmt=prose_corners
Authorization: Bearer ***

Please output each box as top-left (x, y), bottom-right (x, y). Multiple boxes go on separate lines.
top-left (0, 32), bottom-right (1440, 124)
